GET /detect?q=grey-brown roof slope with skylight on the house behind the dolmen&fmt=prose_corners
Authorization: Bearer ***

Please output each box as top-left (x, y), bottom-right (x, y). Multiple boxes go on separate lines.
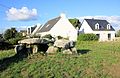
top-left (39, 16), bottom-right (61, 32)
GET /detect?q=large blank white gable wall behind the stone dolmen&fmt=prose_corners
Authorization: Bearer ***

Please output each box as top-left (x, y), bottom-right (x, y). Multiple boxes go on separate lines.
top-left (49, 17), bottom-right (77, 41)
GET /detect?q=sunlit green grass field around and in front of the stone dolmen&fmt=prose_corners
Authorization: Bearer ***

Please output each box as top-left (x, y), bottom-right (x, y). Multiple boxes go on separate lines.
top-left (0, 42), bottom-right (120, 78)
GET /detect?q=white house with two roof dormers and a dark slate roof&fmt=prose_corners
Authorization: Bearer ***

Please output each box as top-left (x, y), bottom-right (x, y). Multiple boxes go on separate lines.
top-left (79, 19), bottom-right (115, 41)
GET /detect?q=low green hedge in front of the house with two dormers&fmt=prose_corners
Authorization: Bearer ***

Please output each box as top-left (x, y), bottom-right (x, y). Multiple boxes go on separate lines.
top-left (78, 34), bottom-right (98, 41)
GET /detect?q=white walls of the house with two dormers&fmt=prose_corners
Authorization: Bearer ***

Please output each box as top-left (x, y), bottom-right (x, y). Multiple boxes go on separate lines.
top-left (79, 20), bottom-right (115, 41)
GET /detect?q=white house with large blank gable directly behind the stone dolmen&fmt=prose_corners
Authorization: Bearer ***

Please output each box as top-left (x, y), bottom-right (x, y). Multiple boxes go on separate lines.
top-left (36, 14), bottom-right (77, 41)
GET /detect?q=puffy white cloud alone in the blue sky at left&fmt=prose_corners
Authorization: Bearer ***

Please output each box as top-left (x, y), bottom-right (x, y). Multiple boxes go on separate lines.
top-left (6, 7), bottom-right (37, 21)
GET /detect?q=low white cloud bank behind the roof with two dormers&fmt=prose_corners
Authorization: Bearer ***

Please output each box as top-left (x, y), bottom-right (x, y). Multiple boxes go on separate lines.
top-left (77, 16), bottom-right (120, 31)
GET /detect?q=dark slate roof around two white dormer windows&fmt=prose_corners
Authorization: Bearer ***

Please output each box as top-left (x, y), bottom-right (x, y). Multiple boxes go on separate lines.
top-left (85, 19), bottom-right (115, 31)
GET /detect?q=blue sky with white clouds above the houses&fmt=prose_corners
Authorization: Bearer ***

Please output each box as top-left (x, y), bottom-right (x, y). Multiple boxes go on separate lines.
top-left (0, 0), bottom-right (120, 33)
